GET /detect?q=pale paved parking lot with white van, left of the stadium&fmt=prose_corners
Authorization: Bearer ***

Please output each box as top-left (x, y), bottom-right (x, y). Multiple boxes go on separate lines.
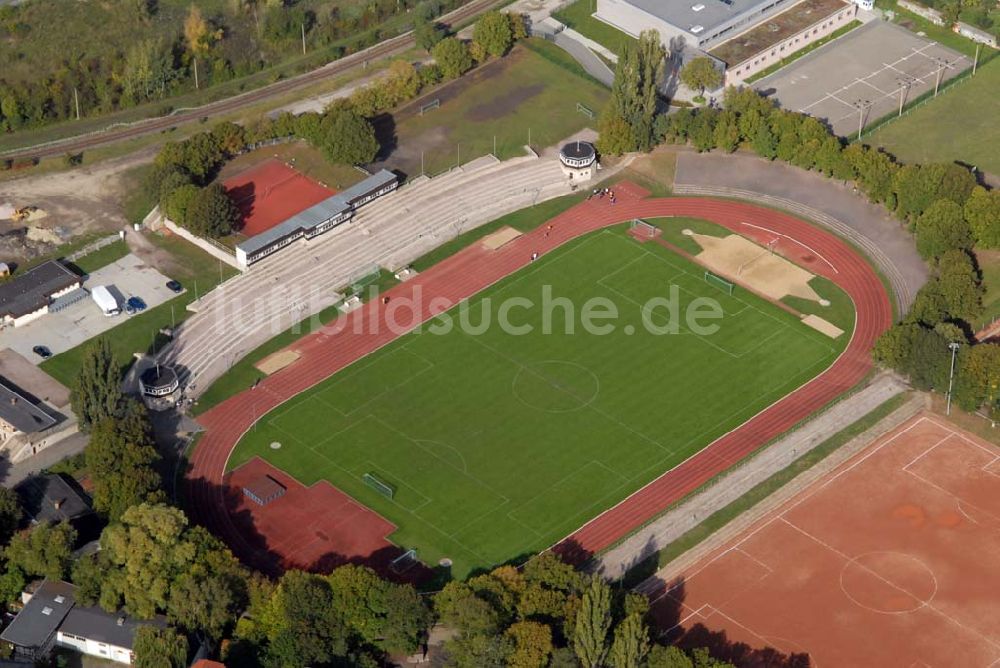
top-left (0, 253), bottom-right (177, 364)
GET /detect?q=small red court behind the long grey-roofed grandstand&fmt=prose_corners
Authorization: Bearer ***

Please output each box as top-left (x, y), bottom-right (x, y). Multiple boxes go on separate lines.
top-left (222, 158), bottom-right (336, 237)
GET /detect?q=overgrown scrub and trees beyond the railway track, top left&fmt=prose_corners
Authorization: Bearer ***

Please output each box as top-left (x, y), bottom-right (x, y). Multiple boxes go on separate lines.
top-left (0, 0), bottom-right (467, 132)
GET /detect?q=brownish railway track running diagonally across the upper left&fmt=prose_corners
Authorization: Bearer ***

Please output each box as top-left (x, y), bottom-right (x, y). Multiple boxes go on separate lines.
top-left (0, 0), bottom-right (505, 160)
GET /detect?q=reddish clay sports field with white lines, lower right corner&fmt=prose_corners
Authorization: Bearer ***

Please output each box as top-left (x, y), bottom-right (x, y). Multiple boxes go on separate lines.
top-left (654, 415), bottom-right (1000, 668)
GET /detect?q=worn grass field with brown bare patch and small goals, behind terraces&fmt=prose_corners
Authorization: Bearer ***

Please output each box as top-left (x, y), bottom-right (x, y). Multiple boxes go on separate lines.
top-left (388, 39), bottom-right (609, 176)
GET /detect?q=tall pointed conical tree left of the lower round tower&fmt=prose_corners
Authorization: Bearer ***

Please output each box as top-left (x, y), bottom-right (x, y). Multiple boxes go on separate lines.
top-left (70, 336), bottom-right (125, 431)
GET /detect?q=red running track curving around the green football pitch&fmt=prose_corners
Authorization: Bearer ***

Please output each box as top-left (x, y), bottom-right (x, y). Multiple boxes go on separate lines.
top-left (186, 183), bottom-right (892, 563)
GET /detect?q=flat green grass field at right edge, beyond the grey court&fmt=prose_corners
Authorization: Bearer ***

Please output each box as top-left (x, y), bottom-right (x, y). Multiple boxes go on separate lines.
top-left (864, 58), bottom-right (1000, 174)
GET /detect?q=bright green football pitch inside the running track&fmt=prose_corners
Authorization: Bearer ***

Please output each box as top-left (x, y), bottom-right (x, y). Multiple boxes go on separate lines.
top-left (229, 228), bottom-right (849, 577)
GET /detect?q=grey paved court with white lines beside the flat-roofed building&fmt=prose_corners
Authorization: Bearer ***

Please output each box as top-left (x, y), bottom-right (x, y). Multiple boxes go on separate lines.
top-left (754, 21), bottom-right (972, 136)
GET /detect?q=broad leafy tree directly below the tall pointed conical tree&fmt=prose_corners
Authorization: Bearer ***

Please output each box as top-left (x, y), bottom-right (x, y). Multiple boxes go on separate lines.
top-left (85, 408), bottom-right (163, 522)
